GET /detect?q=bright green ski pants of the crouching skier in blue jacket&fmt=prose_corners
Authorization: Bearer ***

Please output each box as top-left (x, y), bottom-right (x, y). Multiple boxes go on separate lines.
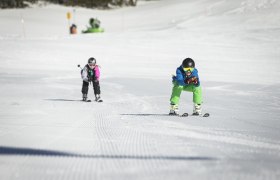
top-left (170, 82), bottom-right (202, 105)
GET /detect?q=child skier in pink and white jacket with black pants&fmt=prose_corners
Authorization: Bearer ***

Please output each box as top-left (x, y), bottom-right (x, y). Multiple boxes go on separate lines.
top-left (82, 57), bottom-right (102, 102)
